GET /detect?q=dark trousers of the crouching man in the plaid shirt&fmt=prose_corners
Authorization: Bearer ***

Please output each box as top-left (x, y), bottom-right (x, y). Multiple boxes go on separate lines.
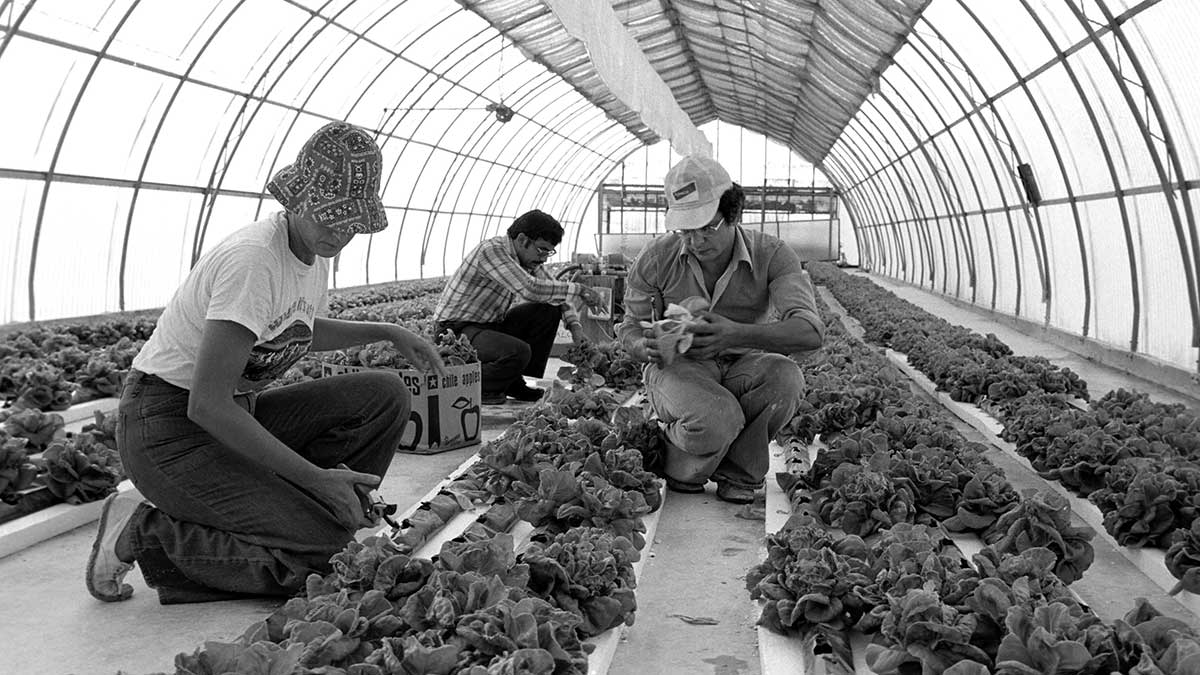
top-left (437, 303), bottom-right (563, 395)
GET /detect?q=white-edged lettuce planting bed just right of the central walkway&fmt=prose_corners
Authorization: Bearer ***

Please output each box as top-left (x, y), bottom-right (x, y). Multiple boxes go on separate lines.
top-left (748, 264), bottom-right (1200, 674)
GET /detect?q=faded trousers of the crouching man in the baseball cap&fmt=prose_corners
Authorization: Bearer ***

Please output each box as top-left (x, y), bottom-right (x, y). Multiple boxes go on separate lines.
top-left (646, 352), bottom-right (804, 489)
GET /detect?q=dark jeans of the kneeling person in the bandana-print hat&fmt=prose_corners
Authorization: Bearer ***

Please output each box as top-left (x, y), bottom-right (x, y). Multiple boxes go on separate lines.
top-left (118, 370), bottom-right (412, 604)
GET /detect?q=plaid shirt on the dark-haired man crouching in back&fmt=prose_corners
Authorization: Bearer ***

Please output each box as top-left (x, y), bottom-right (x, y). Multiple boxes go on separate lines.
top-left (433, 234), bottom-right (582, 329)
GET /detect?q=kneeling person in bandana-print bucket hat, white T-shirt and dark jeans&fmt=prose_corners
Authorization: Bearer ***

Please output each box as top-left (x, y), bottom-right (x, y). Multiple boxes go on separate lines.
top-left (85, 123), bottom-right (444, 604)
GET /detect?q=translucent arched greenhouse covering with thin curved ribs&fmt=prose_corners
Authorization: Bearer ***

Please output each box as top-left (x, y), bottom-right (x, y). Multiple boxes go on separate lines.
top-left (0, 0), bottom-right (1200, 379)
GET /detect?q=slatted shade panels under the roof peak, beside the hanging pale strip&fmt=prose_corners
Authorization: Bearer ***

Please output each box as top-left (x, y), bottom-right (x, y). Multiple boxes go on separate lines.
top-left (460, 0), bottom-right (929, 162)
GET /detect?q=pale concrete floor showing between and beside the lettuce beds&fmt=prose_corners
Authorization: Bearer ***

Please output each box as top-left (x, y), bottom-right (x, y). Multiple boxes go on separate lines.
top-left (0, 283), bottom-right (1200, 675)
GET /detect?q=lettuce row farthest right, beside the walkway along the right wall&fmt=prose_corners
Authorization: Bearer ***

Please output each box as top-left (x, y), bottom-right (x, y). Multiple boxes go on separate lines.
top-left (814, 265), bottom-right (1200, 592)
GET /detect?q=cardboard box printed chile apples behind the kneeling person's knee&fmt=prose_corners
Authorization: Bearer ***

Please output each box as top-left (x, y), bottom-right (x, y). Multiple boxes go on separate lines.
top-left (322, 363), bottom-right (482, 455)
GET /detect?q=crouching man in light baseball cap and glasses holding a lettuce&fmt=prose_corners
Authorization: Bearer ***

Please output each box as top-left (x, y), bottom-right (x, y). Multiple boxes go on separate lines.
top-left (618, 156), bottom-right (824, 503)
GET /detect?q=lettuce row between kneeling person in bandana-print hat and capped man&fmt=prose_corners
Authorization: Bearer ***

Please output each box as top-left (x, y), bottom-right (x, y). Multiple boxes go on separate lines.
top-left (145, 372), bottom-right (661, 675)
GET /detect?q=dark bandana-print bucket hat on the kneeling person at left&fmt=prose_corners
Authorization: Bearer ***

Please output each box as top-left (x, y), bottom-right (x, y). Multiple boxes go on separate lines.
top-left (266, 121), bottom-right (388, 234)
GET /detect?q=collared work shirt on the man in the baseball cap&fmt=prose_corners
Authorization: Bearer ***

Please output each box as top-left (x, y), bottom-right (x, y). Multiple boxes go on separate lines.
top-left (617, 227), bottom-right (824, 353)
